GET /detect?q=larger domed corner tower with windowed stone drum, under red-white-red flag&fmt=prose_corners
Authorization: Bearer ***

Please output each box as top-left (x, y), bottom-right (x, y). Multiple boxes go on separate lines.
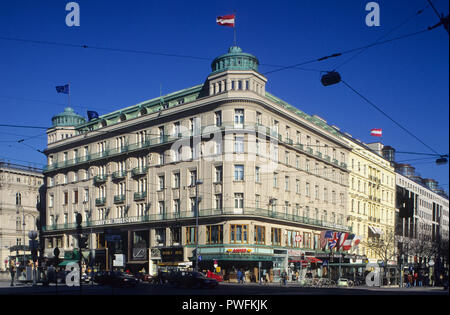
top-left (208, 46), bottom-right (267, 96)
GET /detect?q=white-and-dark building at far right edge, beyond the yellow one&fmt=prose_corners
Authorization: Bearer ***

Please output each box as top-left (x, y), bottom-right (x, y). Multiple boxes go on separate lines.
top-left (383, 147), bottom-right (449, 286)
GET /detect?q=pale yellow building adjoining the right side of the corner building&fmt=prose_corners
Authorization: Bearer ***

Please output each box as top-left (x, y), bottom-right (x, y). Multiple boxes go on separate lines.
top-left (338, 138), bottom-right (396, 265)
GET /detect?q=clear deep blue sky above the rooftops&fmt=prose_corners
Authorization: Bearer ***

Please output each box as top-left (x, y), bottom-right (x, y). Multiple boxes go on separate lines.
top-left (0, 0), bottom-right (449, 191)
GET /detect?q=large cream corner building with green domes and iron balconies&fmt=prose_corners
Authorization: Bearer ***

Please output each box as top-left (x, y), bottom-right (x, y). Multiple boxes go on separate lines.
top-left (44, 47), bottom-right (350, 280)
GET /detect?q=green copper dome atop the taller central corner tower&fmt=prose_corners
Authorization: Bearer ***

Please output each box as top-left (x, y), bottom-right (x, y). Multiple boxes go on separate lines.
top-left (211, 46), bottom-right (259, 73)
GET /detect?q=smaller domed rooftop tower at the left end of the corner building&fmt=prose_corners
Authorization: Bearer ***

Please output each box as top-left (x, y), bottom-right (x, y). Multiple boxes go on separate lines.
top-left (47, 107), bottom-right (86, 144)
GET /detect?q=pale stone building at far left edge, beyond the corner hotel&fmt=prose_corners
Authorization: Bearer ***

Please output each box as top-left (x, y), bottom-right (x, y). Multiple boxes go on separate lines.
top-left (0, 162), bottom-right (44, 270)
